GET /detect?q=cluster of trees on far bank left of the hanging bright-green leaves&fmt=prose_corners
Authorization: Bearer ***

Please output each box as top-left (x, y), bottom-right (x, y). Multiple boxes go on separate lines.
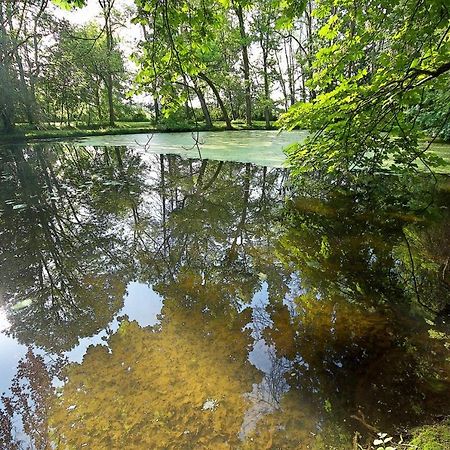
top-left (0, 0), bottom-right (137, 131)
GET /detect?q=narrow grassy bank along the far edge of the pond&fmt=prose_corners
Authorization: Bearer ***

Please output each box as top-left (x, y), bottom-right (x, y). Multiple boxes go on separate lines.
top-left (0, 121), bottom-right (275, 144)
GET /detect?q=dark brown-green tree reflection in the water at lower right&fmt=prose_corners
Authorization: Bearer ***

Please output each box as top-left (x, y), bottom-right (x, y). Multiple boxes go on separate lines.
top-left (263, 192), bottom-right (450, 429)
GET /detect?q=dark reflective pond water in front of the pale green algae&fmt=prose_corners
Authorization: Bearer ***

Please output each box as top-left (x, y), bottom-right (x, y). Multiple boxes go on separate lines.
top-left (0, 139), bottom-right (450, 450)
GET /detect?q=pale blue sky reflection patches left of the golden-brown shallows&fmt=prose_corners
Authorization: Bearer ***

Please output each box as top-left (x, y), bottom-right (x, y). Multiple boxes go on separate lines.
top-left (0, 282), bottom-right (163, 394)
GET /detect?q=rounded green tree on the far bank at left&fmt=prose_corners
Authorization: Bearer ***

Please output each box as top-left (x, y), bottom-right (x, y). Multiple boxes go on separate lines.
top-left (38, 20), bottom-right (127, 125)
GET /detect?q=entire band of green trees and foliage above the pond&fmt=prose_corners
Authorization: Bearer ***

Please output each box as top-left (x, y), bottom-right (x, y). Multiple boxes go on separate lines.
top-left (0, 0), bottom-right (450, 180)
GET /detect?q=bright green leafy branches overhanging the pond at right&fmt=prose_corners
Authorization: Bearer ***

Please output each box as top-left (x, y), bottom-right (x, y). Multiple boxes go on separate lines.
top-left (280, 0), bottom-right (450, 179)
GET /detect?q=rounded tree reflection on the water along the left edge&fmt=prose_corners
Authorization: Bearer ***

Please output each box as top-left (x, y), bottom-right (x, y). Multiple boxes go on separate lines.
top-left (0, 147), bottom-right (138, 351)
